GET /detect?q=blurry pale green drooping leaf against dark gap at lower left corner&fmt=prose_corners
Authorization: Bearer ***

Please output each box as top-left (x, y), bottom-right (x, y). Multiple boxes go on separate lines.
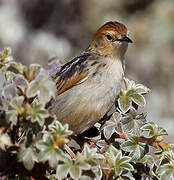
top-left (18, 144), bottom-right (38, 170)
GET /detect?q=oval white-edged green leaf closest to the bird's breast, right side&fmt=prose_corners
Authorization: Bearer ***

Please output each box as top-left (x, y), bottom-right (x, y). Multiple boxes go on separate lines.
top-left (118, 93), bottom-right (131, 113)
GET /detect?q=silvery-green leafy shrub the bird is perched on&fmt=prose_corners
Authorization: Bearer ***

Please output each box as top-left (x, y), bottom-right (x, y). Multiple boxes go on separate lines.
top-left (0, 48), bottom-right (174, 180)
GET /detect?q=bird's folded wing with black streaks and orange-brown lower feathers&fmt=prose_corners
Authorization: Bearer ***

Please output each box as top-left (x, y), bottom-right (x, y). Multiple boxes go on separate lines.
top-left (55, 53), bottom-right (91, 95)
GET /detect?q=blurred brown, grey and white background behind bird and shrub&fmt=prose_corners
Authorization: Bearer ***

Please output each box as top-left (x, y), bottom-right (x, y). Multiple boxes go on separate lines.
top-left (0, 0), bottom-right (174, 141)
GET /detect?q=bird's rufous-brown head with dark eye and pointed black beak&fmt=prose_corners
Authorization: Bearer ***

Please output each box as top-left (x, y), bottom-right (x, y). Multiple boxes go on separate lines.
top-left (91, 21), bottom-right (132, 58)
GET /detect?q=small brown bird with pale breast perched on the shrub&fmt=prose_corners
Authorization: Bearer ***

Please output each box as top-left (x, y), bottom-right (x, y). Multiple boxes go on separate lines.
top-left (51, 21), bottom-right (132, 134)
